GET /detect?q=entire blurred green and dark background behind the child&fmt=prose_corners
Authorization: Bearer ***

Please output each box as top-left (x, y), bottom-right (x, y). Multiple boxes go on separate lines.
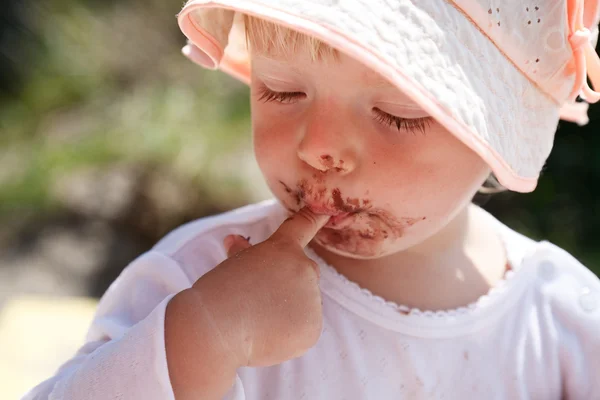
top-left (0, 0), bottom-right (600, 398)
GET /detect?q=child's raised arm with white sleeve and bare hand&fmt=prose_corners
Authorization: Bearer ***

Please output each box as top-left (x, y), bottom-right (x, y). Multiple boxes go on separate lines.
top-left (24, 211), bottom-right (328, 400)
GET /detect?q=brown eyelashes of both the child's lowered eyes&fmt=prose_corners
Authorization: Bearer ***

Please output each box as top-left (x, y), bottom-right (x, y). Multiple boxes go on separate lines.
top-left (258, 86), bottom-right (431, 134)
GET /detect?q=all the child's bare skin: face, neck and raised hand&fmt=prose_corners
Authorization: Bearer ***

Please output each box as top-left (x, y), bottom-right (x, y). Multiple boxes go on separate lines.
top-left (165, 35), bottom-right (506, 400)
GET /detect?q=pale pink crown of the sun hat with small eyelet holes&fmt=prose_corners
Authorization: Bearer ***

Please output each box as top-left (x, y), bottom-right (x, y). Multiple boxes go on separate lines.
top-left (450, 0), bottom-right (600, 104)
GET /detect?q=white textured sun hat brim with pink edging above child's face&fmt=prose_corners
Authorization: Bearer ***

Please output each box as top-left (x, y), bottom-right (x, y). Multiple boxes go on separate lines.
top-left (178, 0), bottom-right (560, 192)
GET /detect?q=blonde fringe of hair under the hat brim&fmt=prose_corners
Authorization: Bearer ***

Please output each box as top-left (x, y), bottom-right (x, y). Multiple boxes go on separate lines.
top-left (244, 15), bottom-right (338, 61)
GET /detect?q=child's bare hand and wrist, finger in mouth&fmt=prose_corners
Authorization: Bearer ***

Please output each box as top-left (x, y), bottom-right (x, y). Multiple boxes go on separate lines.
top-left (165, 210), bottom-right (329, 400)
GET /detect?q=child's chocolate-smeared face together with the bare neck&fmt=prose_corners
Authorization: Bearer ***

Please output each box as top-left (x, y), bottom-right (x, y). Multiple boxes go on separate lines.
top-left (251, 49), bottom-right (507, 309)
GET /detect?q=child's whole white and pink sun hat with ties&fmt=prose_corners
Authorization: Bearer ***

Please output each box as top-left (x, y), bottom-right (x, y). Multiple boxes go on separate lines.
top-left (177, 0), bottom-right (600, 192)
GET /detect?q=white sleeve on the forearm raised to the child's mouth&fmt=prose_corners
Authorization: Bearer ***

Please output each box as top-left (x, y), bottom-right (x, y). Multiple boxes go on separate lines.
top-left (23, 251), bottom-right (193, 400)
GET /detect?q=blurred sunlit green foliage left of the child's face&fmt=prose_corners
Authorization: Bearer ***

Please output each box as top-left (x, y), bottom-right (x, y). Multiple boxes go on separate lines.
top-left (0, 0), bottom-right (250, 218)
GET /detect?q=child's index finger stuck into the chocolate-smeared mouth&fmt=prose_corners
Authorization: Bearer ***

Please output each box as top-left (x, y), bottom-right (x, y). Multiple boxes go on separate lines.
top-left (273, 207), bottom-right (331, 248)
